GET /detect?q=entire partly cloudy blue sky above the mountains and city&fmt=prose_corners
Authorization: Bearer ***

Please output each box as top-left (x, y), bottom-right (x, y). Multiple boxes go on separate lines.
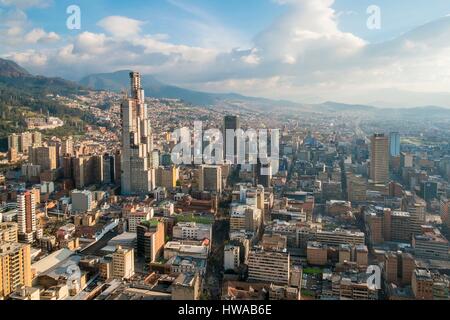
top-left (0, 0), bottom-right (450, 106)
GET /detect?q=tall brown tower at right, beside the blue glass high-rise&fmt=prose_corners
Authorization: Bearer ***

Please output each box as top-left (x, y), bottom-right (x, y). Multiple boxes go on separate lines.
top-left (370, 134), bottom-right (389, 183)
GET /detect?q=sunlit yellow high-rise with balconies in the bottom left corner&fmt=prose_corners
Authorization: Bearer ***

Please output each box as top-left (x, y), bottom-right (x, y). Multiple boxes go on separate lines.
top-left (0, 242), bottom-right (31, 300)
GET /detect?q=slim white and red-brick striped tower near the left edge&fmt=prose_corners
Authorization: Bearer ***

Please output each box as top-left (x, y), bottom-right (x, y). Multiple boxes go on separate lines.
top-left (17, 191), bottom-right (36, 243)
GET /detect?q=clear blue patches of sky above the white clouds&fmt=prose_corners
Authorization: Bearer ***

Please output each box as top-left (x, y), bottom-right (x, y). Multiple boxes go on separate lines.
top-left (22, 0), bottom-right (450, 44)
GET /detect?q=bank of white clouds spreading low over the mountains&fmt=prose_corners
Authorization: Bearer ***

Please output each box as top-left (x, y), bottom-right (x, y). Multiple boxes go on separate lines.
top-left (4, 0), bottom-right (450, 106)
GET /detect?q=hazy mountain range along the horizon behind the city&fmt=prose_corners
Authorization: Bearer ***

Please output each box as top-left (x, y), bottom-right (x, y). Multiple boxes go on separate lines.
top-left (0, 59), bottom-right (450, 119)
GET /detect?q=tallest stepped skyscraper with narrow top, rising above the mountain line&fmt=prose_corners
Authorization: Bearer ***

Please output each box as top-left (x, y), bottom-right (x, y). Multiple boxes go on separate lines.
top-left (121, 72), bottom-right (155, 195)
